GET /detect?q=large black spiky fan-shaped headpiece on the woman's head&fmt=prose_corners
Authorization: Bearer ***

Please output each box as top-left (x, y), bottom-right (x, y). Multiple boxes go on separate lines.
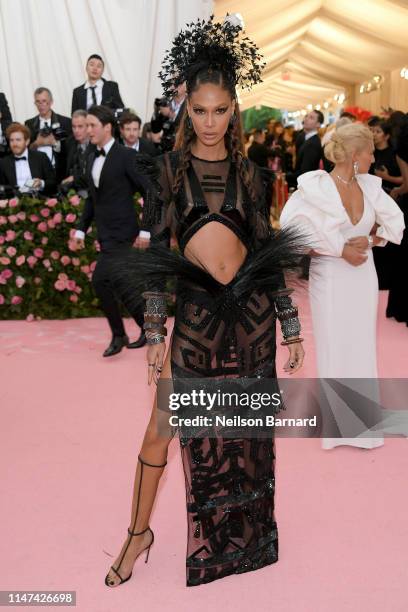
top-left (159, 15), bottom-right (265, 98)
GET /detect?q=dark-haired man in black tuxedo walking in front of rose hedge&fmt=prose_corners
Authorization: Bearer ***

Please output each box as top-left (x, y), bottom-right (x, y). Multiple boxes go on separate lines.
top-left (75, 106), bottom-right (148, 357)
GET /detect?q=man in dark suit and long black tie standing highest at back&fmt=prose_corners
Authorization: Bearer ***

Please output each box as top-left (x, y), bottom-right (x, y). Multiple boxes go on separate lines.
top-left (71, 53), bottom-right (125, 114)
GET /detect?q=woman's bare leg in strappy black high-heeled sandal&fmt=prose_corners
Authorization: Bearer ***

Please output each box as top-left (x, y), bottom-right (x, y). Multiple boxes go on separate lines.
top-left (105, 350), bottom-right (171, 587)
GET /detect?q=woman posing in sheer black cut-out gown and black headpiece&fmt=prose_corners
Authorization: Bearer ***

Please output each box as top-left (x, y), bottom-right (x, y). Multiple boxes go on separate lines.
top-left (105, 14), bottom-right (304, 587)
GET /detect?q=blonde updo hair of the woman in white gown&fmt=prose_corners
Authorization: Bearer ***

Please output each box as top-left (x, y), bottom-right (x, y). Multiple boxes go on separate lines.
top-left (324, 123), bottom-right (373, 164)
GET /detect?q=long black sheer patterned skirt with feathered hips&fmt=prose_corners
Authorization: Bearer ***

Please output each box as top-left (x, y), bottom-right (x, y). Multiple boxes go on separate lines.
top-left (111, 234), bottom-right (298, 586)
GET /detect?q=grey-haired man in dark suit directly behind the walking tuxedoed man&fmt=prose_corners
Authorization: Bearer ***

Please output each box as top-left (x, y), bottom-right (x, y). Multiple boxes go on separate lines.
top-left (62, 110), bottom-right (95, 191)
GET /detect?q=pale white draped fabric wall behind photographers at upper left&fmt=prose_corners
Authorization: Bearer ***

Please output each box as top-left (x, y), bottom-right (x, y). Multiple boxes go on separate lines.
top-left (0, 0), bottom-right (212, 121)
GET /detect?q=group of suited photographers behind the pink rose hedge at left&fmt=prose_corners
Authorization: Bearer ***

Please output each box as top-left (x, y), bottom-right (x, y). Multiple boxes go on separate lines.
top-left (0, 54), bottom-right (186, 197)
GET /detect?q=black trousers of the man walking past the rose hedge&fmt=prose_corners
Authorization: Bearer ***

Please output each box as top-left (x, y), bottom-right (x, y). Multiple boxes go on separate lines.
top-left (92, 245), bottom-right (143, 336)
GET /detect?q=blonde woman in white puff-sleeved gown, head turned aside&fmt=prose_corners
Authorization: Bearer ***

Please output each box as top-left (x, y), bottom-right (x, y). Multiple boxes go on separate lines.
top-left (281, 123), bottom-right (404, 448)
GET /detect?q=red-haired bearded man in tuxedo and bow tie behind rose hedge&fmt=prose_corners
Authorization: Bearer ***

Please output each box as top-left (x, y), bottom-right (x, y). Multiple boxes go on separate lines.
top-left (0, 123), bottom-right (57, 195)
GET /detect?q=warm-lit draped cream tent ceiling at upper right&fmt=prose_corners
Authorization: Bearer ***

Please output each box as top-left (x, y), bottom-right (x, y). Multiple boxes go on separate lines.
top-left (214, 0), bottom-right (408, 110)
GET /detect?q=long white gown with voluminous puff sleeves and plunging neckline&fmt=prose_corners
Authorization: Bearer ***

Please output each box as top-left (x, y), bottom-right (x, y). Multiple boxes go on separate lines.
top-left (280, 170), bottom-right (404, 448)
